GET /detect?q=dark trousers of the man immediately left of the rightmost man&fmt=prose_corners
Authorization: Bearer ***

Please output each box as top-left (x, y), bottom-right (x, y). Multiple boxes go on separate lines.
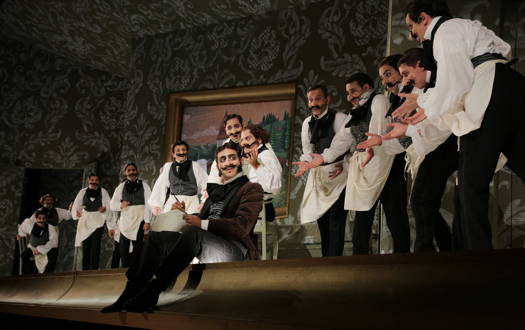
top-left (410, 135), bottom-right (459, 252)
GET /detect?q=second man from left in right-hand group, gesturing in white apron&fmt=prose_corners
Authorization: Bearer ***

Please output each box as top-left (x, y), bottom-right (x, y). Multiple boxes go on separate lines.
top-left (296, 73), bottom-right (410, 254)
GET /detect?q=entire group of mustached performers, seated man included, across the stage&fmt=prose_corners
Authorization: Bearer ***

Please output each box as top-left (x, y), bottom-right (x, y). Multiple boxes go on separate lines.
top-left (14, 0), bottom-right (525, 312)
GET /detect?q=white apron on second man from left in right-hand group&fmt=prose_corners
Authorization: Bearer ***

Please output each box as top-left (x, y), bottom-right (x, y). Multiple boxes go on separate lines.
top-left (345, 147), bottom-right (394, 211)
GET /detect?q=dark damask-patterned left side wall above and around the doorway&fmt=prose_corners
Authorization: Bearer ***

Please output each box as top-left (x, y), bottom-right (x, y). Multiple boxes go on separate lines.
top-left (0, 36), bottom-right (129, 275)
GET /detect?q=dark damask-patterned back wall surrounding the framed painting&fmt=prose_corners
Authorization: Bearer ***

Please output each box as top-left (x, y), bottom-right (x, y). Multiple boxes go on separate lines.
top-left (122, 0), bottom-right (388, 235)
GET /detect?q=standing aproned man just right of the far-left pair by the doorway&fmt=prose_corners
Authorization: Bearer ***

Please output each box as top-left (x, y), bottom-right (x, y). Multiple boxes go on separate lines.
top-left (71, 174), bottom-right (110, 270)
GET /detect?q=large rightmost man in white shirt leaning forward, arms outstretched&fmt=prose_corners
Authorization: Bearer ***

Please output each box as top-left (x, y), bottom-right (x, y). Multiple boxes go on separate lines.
top-left (392, 0), bottom-right (525, 250)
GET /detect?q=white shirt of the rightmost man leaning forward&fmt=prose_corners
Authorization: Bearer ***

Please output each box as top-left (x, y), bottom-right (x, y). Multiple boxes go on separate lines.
top-left (407, 17), bottom-right (511, 153)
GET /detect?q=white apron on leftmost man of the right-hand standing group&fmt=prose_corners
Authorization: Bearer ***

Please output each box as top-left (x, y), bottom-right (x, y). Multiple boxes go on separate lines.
top-left (299, 161), bottom-right (348, 224)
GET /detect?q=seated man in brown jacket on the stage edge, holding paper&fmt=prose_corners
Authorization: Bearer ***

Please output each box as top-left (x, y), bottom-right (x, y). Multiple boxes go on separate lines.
top-left (102, 142), bottom-right (263, 313)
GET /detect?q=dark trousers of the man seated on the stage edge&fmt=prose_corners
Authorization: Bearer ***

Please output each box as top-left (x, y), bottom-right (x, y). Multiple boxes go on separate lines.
top-left (126, 226), bottom-right (247, 290)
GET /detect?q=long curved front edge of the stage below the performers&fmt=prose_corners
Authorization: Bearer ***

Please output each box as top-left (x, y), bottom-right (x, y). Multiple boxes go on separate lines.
top-left (0, 249), bottom-right (525, 329)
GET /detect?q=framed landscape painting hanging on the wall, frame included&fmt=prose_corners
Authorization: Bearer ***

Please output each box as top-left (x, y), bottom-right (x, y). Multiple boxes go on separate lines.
top-left (163, 84), bottom-right (295, 218)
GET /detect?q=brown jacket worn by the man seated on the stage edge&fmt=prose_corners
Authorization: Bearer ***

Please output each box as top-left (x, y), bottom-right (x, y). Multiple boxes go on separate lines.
top-left (200, 182), bottom-right (264, 259)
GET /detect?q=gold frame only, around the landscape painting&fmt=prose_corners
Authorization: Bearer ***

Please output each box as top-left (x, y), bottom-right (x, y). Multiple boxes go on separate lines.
top-left (162, 83), bottom-right (296, 218)
